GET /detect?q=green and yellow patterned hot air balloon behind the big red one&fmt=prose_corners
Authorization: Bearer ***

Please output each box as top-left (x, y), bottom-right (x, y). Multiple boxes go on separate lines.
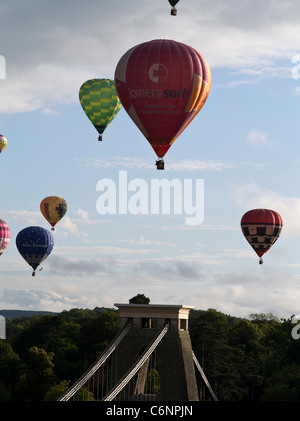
top-left (79, 79), bottom-right (122, 140)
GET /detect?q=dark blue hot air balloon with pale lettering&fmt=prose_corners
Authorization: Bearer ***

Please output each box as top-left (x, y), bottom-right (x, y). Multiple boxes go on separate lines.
top-left (16, 226), bottom-right (54, 276)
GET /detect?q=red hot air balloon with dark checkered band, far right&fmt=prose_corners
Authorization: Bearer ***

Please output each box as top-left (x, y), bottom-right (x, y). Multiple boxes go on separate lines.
top-left (241, 209), bottom-right (283, 264)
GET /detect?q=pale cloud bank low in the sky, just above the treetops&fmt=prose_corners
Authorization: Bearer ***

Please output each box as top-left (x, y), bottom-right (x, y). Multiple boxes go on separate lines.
top-left (0, 261), bottom-right (300, 318)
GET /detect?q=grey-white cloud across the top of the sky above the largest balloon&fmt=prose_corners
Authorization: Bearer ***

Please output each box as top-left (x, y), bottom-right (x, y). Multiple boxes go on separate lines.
top-left (0, 0), bottom-right (300, 113)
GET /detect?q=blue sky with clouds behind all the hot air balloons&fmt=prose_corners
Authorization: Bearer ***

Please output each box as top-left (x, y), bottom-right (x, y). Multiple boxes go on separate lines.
top-left (0, 0), bottom-right (300, 317)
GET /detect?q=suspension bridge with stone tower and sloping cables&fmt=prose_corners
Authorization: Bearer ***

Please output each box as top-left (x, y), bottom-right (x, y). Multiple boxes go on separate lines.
top-left (58, 304), bottom-right (218, 401)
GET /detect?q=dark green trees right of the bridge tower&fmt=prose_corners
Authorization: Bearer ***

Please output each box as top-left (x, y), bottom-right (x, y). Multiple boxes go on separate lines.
top-left (190, 309), bottom-right (300, 401)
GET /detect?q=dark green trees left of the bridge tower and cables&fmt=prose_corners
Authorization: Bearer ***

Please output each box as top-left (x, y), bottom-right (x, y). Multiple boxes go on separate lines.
top-left (0, 307), bottom-right (119, 401)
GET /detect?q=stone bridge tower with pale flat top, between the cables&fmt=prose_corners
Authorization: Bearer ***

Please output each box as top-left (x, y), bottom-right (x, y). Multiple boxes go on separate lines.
top-left (115, 304), bottom-right (199, 401)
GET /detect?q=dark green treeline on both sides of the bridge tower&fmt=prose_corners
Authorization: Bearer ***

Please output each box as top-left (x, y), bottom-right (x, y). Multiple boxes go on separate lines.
top-left (0, 308), bottom-right (300, 401)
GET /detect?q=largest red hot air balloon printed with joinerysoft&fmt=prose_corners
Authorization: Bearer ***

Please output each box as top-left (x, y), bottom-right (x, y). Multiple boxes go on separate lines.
top-left (115, 39), bottom-right (211, 169)
